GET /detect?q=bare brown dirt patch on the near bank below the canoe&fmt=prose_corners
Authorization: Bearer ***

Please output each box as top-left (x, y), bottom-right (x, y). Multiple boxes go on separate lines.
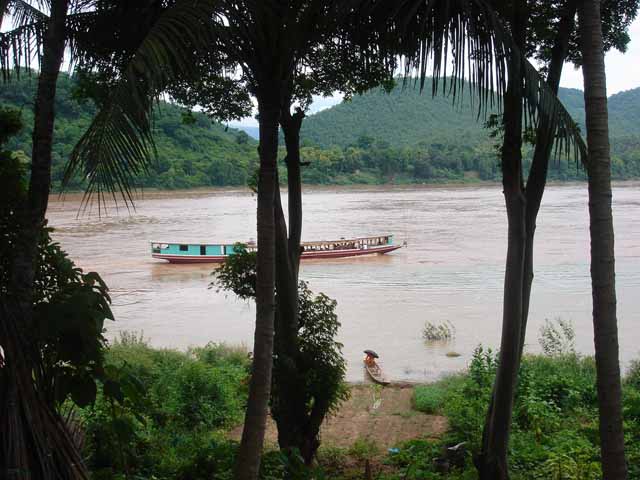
top-left (230, 384), bottom-right (447, 450)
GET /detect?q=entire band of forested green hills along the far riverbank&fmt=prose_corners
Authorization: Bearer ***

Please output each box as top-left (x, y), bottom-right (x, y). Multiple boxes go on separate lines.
top-left (5, 75), bottom-right (640, 188)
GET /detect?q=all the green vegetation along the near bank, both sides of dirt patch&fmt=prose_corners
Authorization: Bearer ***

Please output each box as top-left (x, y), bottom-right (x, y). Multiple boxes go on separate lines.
top-left (76, 324), bottom-right (640, 480)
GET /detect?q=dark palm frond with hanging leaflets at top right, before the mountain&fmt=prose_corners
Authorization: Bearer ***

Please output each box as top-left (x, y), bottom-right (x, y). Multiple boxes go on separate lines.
top-left (370, 0), bottom-right (586, 159)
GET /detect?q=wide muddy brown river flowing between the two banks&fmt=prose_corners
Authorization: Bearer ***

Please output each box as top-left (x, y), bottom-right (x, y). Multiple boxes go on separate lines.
top-left (49, 183), bottom-right (640, 381)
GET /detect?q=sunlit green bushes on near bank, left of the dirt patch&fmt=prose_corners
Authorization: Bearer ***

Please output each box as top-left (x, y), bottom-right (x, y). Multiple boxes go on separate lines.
top-left (79, 334), bottom-right (248, 480)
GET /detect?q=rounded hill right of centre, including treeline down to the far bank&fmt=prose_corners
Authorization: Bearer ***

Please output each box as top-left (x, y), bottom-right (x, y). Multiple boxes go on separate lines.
top-left (294, 81), bottom-right (640, 183)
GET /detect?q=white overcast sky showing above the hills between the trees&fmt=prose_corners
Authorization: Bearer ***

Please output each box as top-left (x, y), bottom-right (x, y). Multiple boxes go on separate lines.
top-left (230, 19), bottom-right (640, 127)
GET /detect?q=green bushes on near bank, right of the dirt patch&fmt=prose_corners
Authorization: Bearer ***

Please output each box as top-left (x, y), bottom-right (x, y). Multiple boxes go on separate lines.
top-left (400, 348), bottom-right (640, 480)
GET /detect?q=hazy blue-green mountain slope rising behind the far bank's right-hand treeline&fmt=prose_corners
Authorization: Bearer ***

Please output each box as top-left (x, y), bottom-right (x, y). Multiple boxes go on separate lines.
top-left (301, 81), bottom-right (640, 148)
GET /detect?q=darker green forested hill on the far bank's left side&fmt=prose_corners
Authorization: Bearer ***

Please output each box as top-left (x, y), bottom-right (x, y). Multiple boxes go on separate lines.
top-left (0, 75), bottom-right (257, 188)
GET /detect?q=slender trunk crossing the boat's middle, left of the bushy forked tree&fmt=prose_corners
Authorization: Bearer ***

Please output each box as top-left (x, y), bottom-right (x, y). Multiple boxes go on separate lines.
top-left (234, 95), bottom-right (280, 480)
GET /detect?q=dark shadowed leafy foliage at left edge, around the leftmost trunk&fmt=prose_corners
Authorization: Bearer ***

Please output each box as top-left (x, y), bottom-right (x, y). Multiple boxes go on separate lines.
top-left (0, 108), bottom-right (113, 407)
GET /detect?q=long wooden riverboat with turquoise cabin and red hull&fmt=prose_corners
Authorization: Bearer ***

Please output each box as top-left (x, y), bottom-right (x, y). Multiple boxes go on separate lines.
top-left (151, 235), bottom-right (401, 263)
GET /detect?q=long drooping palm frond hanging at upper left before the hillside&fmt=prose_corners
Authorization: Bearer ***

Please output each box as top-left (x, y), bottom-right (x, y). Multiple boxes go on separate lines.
top-left (63, 0), bottom-right (216, 208)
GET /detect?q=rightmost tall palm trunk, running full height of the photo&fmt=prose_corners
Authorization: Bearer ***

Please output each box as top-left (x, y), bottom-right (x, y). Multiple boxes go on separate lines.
top-left (578, 0), bottom-right (627, 480)
